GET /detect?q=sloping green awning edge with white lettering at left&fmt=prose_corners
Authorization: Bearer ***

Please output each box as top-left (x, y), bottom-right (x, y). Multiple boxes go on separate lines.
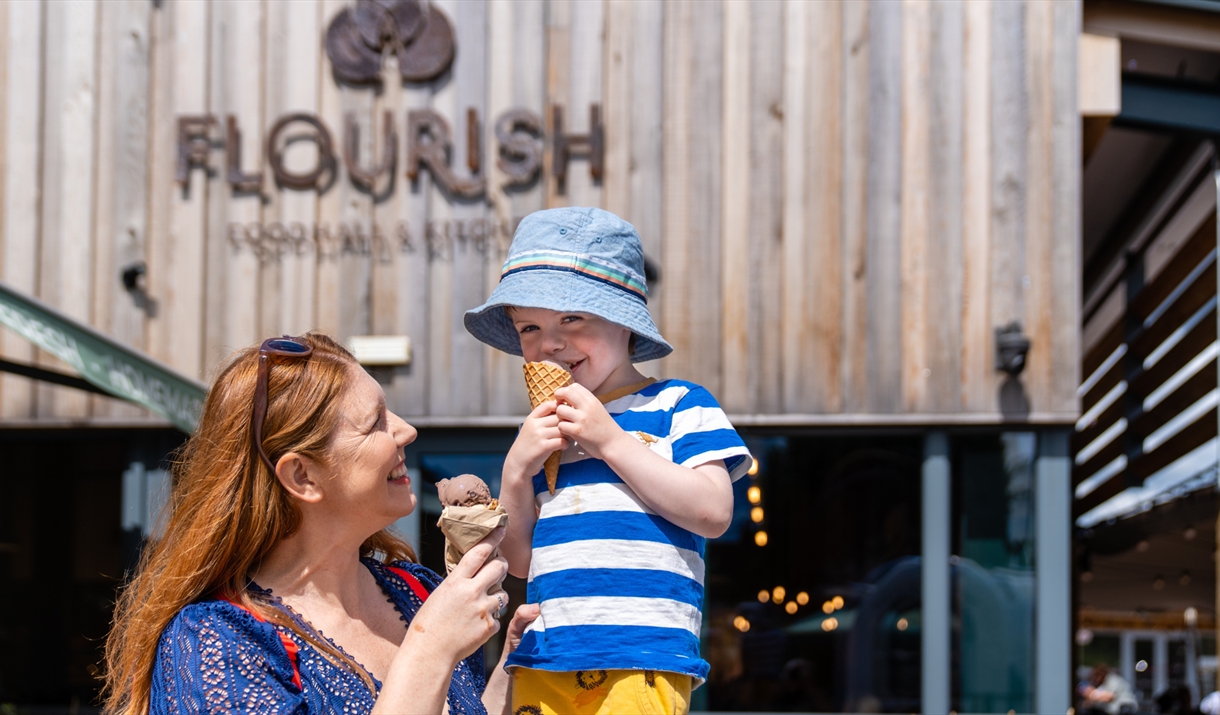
top-left (0, 283), bottom-right (207, 434)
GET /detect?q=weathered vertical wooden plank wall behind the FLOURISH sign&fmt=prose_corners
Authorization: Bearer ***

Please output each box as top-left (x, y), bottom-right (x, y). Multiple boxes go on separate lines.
top-left (0, 0), bottom-right (1081, 423)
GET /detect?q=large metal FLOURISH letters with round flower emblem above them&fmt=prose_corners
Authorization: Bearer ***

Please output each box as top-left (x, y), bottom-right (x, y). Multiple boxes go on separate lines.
top-left (174, 0), bottom-right (605, 199)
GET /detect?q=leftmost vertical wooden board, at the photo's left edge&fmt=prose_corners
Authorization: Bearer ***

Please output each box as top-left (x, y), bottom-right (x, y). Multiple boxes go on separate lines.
top-left (0, 1), bottom-right (46, 419)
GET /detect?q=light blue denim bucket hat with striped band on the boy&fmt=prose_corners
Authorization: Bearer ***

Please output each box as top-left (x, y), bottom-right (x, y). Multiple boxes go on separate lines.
top-left (464, 207), bottom-right (673, 362)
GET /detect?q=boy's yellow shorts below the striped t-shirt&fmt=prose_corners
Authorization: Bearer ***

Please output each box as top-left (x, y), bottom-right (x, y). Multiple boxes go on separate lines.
top-left (511, 667), bottom-right (691, 715)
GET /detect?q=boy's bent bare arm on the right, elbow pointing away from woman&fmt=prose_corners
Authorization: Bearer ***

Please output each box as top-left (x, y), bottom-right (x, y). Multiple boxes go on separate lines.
top-left (553, 384), bottom-right (733, 534)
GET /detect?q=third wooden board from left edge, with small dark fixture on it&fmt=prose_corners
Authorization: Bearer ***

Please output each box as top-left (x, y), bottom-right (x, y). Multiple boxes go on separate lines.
top-left (90, 0), bottom-right (151, 417)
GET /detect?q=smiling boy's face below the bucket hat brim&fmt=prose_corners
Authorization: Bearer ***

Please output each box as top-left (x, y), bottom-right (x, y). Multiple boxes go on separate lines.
top-left (508, 307), bottom-right (632, 394)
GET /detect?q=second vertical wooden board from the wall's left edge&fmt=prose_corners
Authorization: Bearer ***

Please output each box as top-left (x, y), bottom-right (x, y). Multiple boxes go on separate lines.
top-left (38, 0), bottom-right (99, 417)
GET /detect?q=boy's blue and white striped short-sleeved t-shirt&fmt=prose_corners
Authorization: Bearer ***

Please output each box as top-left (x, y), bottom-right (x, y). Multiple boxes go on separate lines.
top-left (508, 379), bottom-right (752, 683)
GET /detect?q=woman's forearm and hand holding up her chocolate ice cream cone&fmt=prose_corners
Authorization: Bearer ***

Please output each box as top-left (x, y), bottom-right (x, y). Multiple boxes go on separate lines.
top-left (373, 528), bottom-right (509, 714)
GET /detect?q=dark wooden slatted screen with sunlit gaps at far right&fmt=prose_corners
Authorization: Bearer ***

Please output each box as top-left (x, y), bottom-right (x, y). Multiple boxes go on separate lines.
top-left (1074, 159), bottom-right (1218, 514)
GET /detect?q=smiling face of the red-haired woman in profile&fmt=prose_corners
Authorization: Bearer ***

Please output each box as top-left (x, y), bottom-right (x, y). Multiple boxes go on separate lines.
top-left (321, 365), bottom-right (417, 522)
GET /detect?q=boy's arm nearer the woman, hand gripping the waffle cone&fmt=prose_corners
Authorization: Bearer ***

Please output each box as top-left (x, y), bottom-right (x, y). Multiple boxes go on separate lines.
top-left (500, 401), bottom-right (567, 578)
